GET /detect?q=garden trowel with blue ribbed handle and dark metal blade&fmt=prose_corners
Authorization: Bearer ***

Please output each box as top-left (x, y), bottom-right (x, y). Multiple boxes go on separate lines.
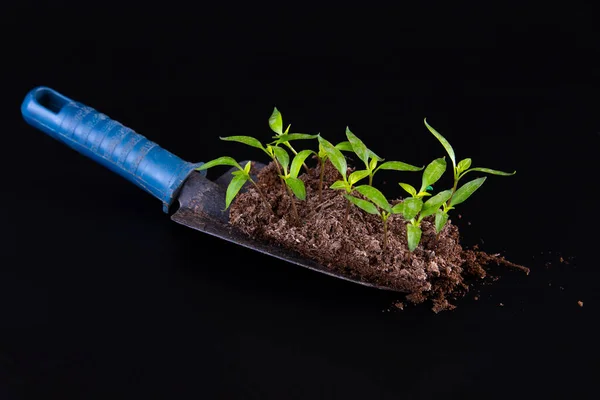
top-left (21, 87), bottom-right (392, 290)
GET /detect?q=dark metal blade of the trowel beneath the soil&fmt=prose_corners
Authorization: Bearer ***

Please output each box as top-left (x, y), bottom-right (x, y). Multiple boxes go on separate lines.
top-left (171, 162), bottom-right (394, 290)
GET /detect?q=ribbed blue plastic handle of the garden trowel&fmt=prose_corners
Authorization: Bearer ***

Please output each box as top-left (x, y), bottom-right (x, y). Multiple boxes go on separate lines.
top-left (21, 86), bottom-right (206, 212)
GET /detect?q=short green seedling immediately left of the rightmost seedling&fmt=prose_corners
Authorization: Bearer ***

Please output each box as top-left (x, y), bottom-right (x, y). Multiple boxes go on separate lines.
top-left (397, 157), bottom-right (452, 252)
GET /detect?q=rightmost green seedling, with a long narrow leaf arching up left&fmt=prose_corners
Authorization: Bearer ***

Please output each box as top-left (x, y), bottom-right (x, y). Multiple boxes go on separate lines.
top-left (423, 118), bottom-right (517, 236)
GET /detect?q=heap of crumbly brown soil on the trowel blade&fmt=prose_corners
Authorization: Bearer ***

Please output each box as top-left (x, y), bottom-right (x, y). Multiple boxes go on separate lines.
top-left (230, 159), bottom-right (528, 312)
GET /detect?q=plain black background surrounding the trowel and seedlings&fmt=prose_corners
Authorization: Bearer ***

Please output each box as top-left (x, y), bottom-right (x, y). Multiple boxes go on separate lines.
top-left (0, 2), bottom-right (600, 399)
